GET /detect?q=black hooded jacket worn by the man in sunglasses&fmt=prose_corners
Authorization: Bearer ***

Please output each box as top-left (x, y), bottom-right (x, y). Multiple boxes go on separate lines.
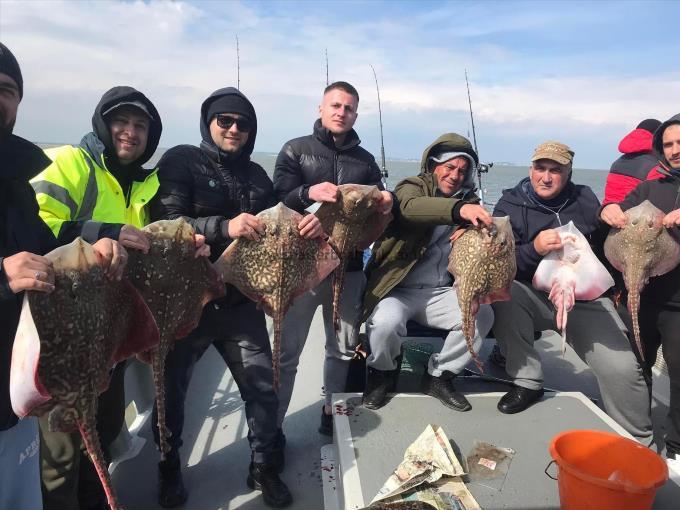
top-left (151, 87), bottom-right (275, 260)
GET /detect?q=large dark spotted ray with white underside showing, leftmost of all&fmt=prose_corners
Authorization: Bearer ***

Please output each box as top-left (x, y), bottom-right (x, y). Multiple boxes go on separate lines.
top-left (10, 238), bottom-right (159, 510)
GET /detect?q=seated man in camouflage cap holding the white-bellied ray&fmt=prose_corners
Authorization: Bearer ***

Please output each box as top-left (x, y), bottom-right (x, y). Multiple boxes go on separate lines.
top-left (491, 142), bottom-right (652, 445)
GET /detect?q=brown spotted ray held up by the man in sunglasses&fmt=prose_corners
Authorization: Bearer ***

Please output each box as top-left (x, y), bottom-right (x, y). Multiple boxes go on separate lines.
top-left (215, 203), bottom-right (339, 389)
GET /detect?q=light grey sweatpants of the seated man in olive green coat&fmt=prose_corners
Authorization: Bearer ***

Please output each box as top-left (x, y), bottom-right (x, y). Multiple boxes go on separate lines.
top-left (366, 287), bottom-right (493, 377)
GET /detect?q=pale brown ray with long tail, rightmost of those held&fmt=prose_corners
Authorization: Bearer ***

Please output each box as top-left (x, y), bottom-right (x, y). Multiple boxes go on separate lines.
top-left (604, 200), bottom-right (680, 359)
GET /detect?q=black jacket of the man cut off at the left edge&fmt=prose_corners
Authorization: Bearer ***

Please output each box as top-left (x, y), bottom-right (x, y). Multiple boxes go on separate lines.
top-left (0, 135), bottom-right (56, 430)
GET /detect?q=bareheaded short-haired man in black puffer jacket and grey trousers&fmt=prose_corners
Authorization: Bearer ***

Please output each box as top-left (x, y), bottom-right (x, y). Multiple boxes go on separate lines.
top-left (274, 82), bottom-right (398, 435)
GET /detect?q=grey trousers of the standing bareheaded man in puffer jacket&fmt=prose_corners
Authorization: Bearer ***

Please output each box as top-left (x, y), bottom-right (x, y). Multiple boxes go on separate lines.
top-left (278, 271), bottom-right (366, 427)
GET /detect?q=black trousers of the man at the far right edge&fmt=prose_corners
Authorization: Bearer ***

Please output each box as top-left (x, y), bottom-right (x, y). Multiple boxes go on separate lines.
top-left (640, 303), bottom-right (680, 454)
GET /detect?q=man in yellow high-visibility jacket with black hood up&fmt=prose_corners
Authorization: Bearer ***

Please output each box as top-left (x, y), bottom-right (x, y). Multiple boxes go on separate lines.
top-left (31, 87), bottom-right (162, 510)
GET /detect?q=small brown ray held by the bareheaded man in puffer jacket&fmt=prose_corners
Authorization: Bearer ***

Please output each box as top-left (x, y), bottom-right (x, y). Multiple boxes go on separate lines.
top-left (314, 184), bottom-right (392, 331)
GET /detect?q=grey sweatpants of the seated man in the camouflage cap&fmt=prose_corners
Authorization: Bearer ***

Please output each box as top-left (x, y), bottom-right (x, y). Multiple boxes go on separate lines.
top-left (491, 281), bottom-right (652, 445)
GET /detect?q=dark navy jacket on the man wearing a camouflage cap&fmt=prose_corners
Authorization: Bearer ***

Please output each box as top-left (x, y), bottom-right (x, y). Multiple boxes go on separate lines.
top-left (493, 177), bottom-right (604, 283)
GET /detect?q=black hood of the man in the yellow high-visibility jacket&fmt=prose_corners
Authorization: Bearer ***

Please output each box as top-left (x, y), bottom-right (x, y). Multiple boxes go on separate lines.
top-left (88, 86), bottom-right (163, 167)
